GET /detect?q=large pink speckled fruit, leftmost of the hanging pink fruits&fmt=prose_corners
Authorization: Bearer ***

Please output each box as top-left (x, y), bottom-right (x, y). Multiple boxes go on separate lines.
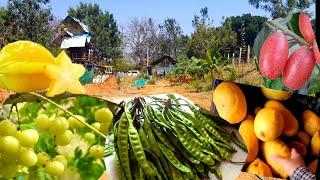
top-left (259, 32), bottom-right (289, 80)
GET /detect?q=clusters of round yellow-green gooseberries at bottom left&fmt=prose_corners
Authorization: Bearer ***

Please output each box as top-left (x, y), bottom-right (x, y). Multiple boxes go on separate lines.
top-left (0, 96), bottom-right (113, 179)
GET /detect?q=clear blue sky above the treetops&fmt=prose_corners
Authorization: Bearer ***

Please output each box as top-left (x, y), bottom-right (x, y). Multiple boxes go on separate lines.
top-left (0, 0), bottom-right (316, 34)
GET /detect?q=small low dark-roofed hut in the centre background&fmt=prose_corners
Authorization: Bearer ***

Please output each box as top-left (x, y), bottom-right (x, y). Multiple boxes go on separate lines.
top-left (148, 55), bottom-right (177, 76)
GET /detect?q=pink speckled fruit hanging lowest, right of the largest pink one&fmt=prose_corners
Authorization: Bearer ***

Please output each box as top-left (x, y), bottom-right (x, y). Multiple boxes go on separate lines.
top-left (283, 46), bottom-right (315, 90)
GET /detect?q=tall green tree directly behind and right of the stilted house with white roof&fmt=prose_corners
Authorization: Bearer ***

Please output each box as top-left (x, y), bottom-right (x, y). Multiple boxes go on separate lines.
top-left (68, 2), bottom-right (122, 59)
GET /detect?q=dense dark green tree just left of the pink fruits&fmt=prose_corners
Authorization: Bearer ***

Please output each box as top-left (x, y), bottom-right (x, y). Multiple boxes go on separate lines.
top-left (223, 14), bottom-right (267, 47)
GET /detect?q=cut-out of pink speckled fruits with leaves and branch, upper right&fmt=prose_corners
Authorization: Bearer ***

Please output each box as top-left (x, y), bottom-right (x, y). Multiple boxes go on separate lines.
top-left (253, 12), bottom-right (320, 95)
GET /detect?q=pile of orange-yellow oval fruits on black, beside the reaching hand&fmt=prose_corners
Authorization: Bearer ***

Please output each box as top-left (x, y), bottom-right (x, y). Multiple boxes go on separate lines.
top-left (213, 81), bottom-right (320, 178)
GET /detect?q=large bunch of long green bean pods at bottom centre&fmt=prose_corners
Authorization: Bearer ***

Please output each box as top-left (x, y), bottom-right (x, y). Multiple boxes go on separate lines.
top-left (114, 95), bottom-right (243, 180)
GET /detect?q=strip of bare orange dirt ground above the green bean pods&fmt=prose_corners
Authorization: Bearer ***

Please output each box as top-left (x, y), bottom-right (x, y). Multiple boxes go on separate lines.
top-left (85, 77), bottom-right (212, 110)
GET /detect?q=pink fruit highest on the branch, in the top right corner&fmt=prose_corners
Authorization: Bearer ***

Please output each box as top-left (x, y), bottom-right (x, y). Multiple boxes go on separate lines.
top-left (299, 12), bottom-right (315, 44)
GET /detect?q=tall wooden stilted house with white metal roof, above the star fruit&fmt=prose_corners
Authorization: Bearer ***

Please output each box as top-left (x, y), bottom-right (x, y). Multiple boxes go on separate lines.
top-left (53, 16), bottom-right (103, 65)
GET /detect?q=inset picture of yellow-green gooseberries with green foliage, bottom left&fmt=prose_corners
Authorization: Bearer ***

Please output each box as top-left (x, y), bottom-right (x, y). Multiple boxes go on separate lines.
top-left (0, 94), bottom-right (113, 179)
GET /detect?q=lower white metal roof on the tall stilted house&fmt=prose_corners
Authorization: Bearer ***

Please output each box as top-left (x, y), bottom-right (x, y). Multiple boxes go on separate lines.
top-left (60, 34), bottom-right (91, 49)
